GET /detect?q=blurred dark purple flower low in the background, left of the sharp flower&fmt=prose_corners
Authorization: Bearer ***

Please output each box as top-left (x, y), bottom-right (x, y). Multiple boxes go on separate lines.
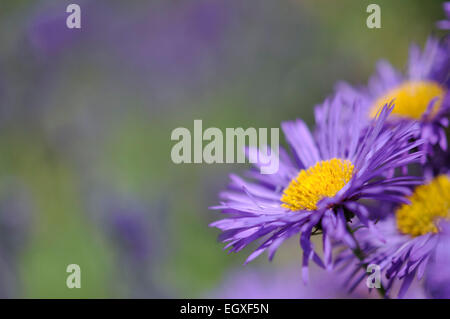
top-left (87, 191), bottom-right (166, 298)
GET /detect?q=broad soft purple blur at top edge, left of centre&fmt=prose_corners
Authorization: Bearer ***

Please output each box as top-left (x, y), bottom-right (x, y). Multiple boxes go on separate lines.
top-left (109, 0), bottom-right (230, 80)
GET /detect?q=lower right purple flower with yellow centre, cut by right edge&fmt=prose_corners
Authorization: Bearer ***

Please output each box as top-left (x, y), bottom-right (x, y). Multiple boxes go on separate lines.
top-left (337, 175), bottom-right (450, 298)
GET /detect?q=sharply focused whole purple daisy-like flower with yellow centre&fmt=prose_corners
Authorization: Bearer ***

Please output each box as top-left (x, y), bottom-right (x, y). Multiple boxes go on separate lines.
top-left (210, 97), bottom-right (422, 282)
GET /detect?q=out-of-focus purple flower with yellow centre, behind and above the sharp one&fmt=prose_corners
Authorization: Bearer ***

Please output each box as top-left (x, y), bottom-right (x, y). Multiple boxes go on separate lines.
top-left (336, 38), bottom-right (450, 154)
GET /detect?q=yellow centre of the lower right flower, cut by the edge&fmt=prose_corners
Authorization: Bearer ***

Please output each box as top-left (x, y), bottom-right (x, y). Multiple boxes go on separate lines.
top-left (395, 175), bottom-right (450, 237)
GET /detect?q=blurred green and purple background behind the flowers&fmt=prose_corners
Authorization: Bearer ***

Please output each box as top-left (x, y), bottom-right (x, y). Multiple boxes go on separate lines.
top-left (0, 0), bottom-right (443, 298)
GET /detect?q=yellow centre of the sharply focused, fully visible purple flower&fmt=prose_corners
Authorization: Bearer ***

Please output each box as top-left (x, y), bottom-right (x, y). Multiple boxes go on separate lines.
top-left (281, 158), bottom-right (354, 211)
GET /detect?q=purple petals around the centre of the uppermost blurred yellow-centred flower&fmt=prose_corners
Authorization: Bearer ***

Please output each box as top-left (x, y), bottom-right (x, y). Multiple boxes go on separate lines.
top-left (336, 37), bottom-right (450, 155)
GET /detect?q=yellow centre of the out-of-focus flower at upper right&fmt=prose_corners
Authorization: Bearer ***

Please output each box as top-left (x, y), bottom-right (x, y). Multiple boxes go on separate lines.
top-left (370, 81), bottom-right (445, 120)
